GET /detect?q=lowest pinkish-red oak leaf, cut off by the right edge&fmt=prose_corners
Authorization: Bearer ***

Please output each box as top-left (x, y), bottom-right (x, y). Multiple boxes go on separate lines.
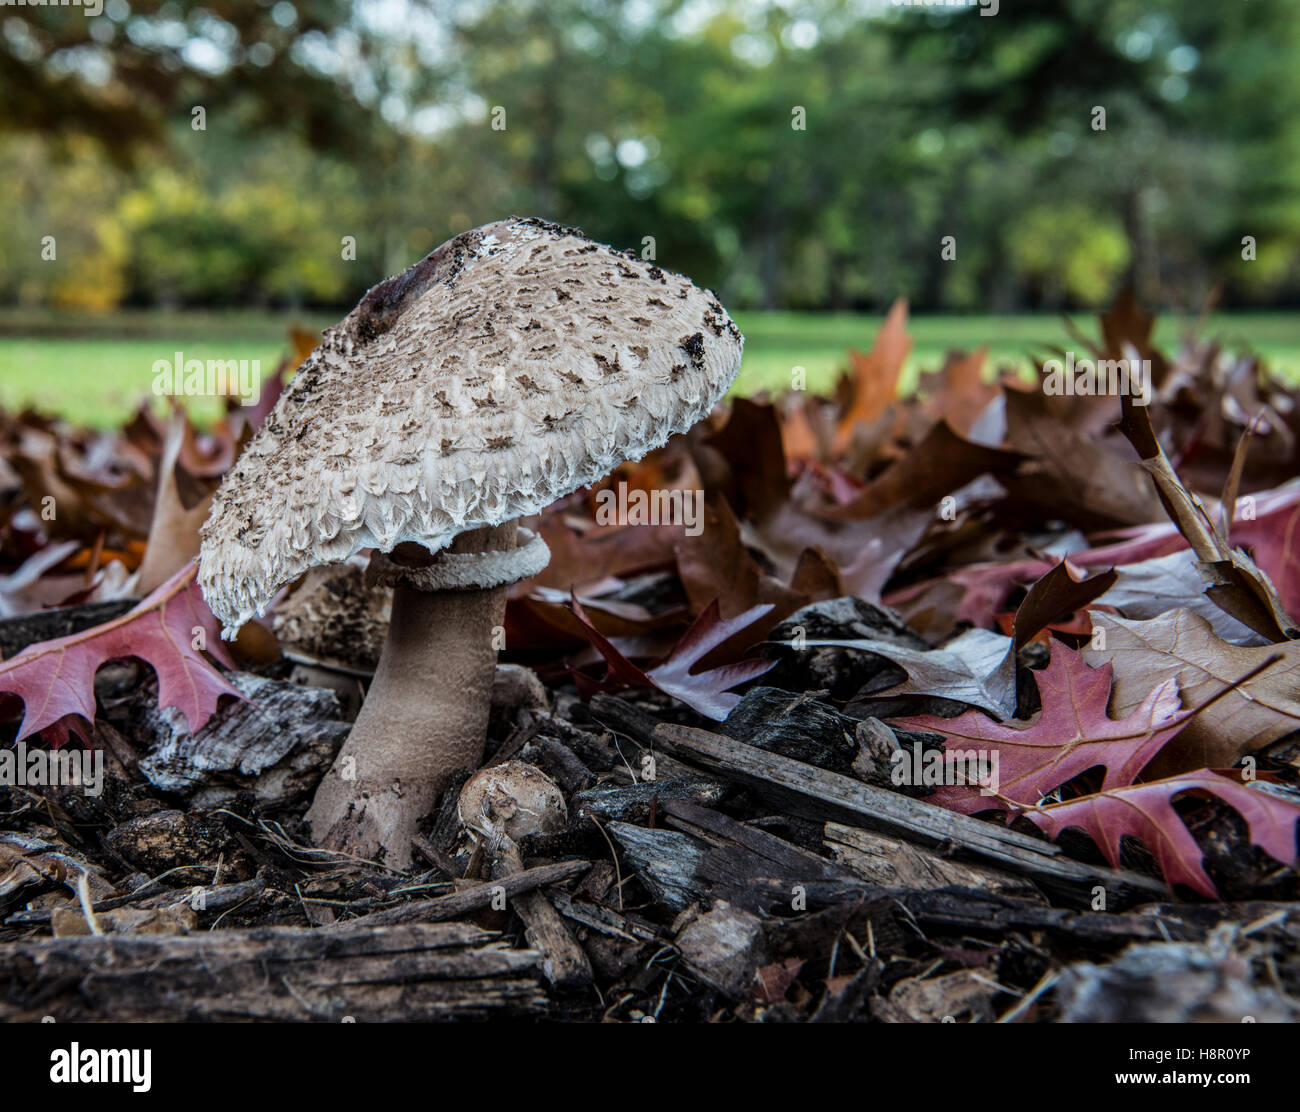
top-left (1028, 769), bottom-right (1300, 899)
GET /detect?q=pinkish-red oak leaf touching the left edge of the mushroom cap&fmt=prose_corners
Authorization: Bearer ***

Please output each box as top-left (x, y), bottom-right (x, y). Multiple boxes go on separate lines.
top-left (0, 563), bottom-right (243, 748)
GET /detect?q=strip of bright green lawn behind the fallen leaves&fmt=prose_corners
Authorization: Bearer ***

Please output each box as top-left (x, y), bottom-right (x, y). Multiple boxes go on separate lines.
top-left (0, 310), bottom-right (1300, 427)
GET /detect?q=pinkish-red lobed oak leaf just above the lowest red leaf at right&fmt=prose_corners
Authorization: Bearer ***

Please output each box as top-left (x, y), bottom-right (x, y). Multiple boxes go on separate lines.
top-left (896, 644), bottom-right (1188, 814)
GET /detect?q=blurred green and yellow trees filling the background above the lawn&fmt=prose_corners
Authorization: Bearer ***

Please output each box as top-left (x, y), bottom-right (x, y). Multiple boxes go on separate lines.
top-left (0, 0), bottom-right (1300, 312)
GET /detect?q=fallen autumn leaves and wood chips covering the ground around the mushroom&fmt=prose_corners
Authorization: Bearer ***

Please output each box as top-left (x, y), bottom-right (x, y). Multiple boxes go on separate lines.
top-left (0, 295), bottom-right (1300, 1022)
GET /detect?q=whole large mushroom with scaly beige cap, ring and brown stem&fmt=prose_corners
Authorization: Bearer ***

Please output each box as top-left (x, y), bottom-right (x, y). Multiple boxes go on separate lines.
top-left (199, 218), bottom-right (744, 866)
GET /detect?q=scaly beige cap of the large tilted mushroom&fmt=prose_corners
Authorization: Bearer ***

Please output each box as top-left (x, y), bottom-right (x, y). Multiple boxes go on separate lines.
top-left (199, 218), bottom-right (744, 636)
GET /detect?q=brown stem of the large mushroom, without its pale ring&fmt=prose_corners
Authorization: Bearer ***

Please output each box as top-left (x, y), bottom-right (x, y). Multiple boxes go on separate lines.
top-left (307, 522), bottom-right (516, 869)
